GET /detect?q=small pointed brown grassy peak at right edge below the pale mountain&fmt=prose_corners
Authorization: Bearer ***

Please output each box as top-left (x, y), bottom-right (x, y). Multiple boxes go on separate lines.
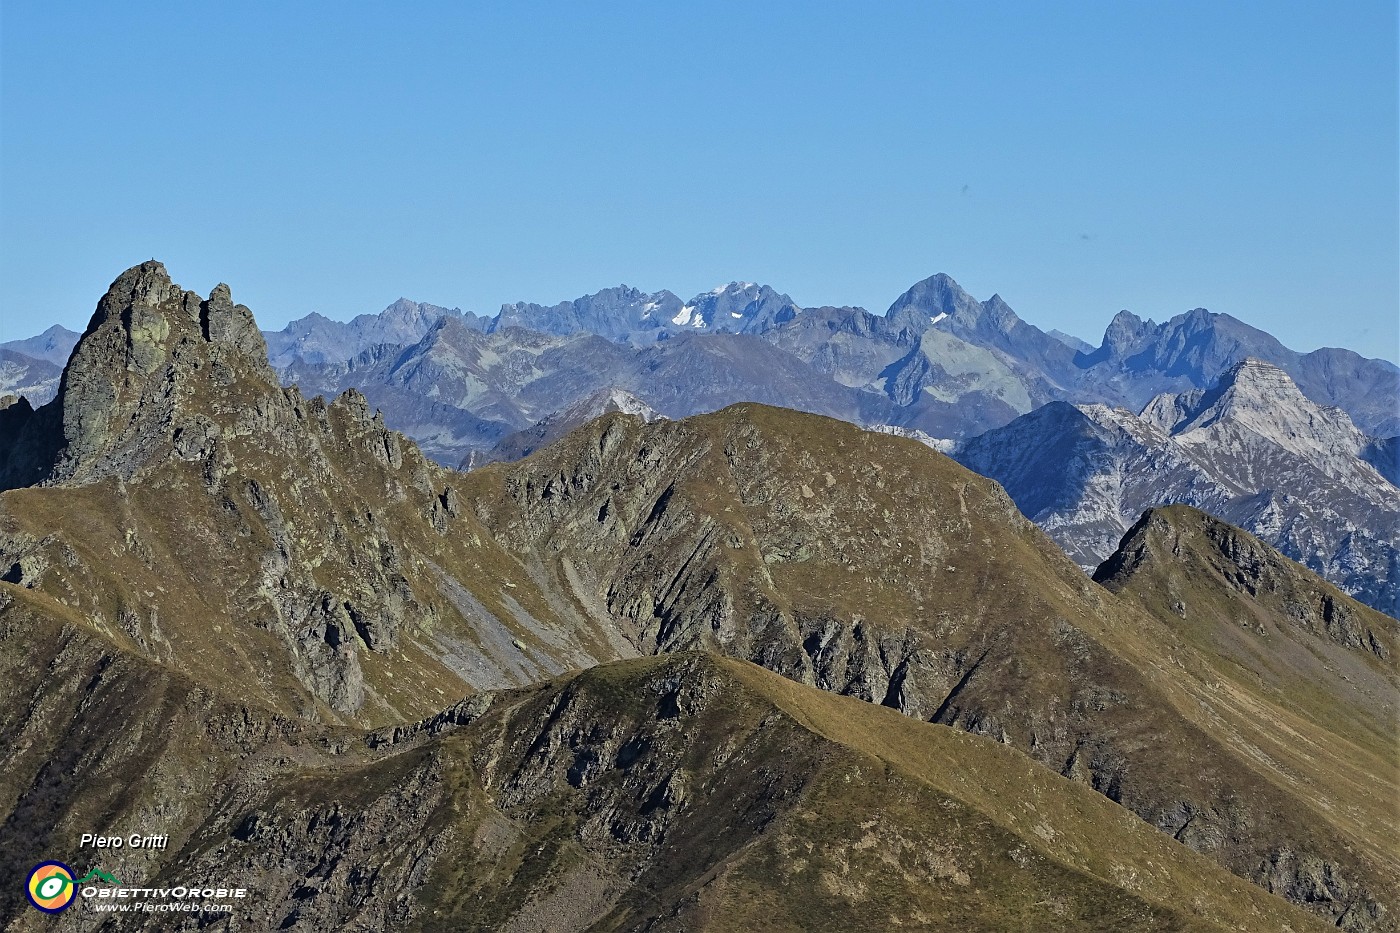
top-left (1095, 506), bottom-right (1400, 879)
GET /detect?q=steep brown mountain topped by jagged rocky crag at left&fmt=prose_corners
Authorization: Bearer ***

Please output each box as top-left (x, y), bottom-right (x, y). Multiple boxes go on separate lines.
top-left (0, 262), bottom-right (613, 717)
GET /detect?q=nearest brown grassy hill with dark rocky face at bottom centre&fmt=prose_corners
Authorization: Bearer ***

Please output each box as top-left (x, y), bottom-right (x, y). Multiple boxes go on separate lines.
top-left (0, 653), bottom-right (1323, 930)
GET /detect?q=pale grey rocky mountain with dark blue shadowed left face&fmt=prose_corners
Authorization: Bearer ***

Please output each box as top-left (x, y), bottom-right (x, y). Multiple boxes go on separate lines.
top-left (953, 360), bottom-right (1400, 615)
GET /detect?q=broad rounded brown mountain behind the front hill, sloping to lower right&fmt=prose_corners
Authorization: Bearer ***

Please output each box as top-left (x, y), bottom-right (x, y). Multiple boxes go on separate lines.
top-left (463, 405), bottom-right (1400, 927)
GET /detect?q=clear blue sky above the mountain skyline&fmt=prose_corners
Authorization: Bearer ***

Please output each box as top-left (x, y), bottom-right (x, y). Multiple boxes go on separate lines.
top-left (0, 0), bottom-right (1400, 360)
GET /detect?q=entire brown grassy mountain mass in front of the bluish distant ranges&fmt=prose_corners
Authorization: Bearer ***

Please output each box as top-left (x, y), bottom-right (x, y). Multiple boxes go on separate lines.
top-left (0, 263), bottom-right (1400, 930)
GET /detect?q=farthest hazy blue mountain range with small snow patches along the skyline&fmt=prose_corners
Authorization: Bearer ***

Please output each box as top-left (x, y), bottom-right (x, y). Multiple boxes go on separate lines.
top-left (254, 268), bottom-right (1400, 437)
